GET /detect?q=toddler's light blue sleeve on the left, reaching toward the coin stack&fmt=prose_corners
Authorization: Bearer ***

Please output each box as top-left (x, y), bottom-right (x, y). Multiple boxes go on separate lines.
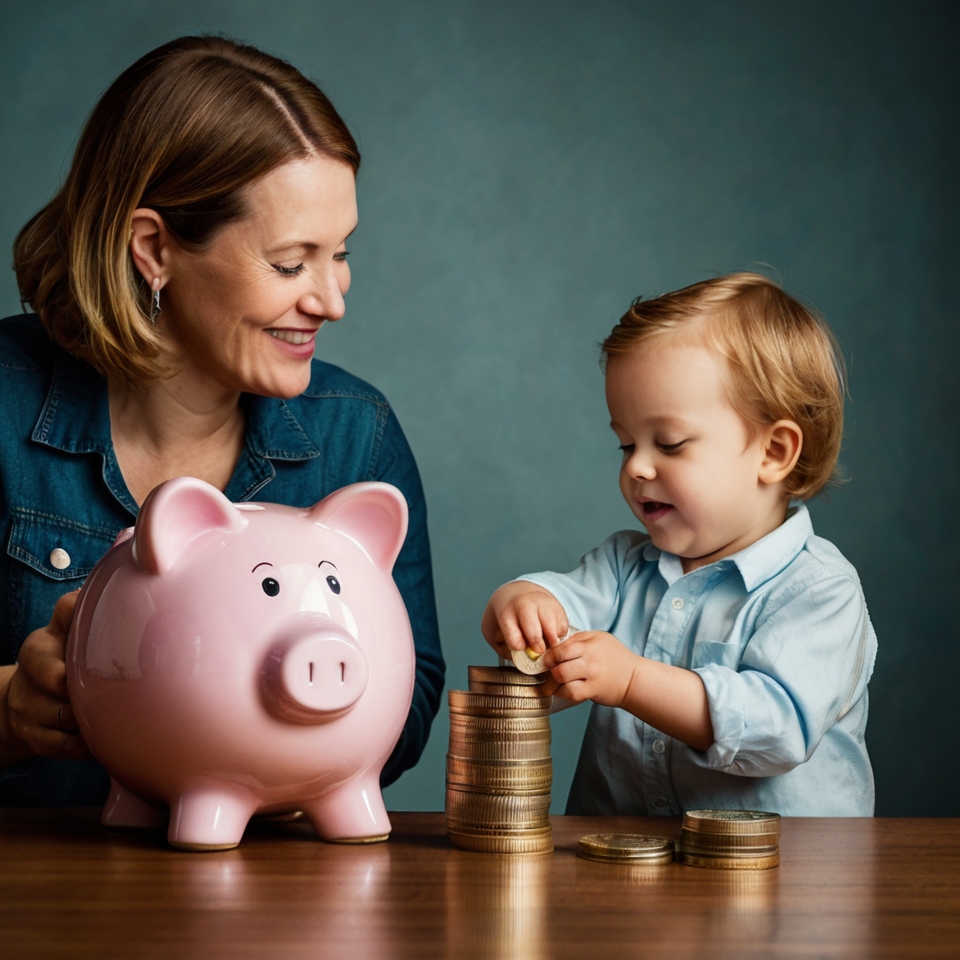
top-left (517, 530), bottom-right (636, 630)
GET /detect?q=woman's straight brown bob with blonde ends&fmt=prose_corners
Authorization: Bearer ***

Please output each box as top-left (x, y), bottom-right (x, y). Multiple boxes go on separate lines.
top-left (14, 36), bottom-right (360, 383)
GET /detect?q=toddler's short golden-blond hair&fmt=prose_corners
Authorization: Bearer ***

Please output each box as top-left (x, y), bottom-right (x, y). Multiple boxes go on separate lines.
top-left (601, 273), bottom-right (846, 500)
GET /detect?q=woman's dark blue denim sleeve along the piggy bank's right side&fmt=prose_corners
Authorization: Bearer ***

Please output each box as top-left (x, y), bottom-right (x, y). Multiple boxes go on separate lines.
top-left (372, 411), bottom-right (446, 786)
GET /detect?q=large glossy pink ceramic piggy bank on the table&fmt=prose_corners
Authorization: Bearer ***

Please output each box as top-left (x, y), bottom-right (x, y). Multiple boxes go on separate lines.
top-left (67, 477), bottom-right (415, 850)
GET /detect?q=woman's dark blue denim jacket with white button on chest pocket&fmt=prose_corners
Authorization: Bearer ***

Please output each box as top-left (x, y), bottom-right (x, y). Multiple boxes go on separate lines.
top-left (0, 314), bottom-right (444, 806)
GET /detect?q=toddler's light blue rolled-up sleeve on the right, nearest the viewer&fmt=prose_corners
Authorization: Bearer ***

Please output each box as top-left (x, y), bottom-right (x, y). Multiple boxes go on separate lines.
top-left (694, 576), bottom-right (877, 777)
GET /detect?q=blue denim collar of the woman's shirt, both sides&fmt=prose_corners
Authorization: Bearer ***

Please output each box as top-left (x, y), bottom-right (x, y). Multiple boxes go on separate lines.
top-left (33, 352), bottom-right (320, 460)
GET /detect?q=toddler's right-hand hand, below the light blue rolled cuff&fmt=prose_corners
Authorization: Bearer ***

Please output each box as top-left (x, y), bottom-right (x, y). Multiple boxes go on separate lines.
top-left (543, 630), bottom-right (642, 707)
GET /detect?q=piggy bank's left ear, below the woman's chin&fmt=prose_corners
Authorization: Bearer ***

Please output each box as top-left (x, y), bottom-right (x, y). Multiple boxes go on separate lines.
top-left (133, 477), bottom-right (247, 575)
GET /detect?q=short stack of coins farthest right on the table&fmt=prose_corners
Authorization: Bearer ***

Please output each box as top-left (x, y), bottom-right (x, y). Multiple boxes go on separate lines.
top-left (677, 810), bottom-right (780, 870)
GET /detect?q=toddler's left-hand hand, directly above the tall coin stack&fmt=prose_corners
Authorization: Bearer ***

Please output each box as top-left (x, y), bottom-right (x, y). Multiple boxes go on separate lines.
top-left (480, 580), bottom-right (569, 660)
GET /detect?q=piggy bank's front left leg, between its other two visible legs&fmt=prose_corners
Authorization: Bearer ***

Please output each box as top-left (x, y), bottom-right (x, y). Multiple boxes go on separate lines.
top-left (167, 779), bottom-right (260, 850)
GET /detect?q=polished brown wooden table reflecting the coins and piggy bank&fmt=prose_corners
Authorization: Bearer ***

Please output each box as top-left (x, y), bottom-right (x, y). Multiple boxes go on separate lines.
top-left (0, 810), bottom-right (960, 960)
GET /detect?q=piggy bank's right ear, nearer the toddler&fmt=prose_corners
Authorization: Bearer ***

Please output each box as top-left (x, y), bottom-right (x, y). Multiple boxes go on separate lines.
top-left (310, 483), bottom-right (407, 573)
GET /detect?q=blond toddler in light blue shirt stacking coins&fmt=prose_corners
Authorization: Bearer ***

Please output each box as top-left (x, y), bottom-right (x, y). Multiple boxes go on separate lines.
top-left (482, 273), bottom-right (877, 816)
